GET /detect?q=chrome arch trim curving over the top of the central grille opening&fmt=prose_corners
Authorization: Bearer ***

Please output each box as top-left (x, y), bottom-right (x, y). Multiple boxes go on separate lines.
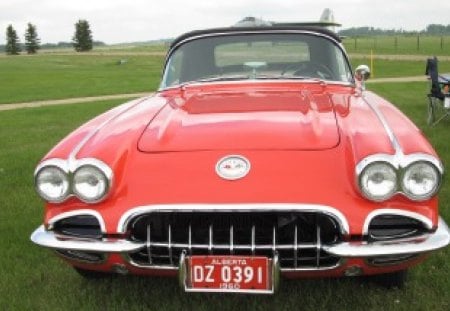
top-left (117, 203), bottom-right (350, 235)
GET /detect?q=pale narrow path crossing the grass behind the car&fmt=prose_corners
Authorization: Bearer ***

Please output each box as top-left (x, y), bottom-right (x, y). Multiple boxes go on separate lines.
top-left (0, 75), bottom-right (427, 111)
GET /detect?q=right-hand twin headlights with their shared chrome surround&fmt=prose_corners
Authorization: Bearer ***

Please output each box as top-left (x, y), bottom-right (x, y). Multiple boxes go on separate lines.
top-left (357, 155), bottom-right (443, 202)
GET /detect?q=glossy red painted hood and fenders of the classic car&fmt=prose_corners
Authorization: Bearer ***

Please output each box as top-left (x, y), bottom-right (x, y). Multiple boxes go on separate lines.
top-left (40, 82), bottom-right (438, 274)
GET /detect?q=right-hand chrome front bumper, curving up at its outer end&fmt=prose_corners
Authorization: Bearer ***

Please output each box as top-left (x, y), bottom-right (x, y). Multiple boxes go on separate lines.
top-left (323, 218), bottom-right (450, 258)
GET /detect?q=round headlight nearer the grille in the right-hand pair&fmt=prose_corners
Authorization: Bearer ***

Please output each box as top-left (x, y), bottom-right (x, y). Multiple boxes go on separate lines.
top-left (359, 162), bottom-right (397, 201)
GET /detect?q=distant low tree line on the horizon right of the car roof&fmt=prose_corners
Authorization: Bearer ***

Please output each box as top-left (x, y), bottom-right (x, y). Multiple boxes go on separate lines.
top-left (339, 24), bottom-right (450, 37)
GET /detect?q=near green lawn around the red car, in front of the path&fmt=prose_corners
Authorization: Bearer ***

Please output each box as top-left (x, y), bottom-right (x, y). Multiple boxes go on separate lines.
top-left (0, 82), bottom-right (450, 310)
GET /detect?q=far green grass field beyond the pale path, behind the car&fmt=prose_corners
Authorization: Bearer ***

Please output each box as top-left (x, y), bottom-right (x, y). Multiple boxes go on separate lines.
top-left (0, 45), bottom-right (450, 104)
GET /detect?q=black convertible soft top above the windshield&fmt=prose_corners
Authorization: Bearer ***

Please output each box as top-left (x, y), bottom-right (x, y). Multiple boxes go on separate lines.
top-left (170, 24), bottom-right (341, 49)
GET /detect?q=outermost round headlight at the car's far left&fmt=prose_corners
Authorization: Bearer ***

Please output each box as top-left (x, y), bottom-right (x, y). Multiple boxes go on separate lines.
top-left (35, 166), bottom-right (70, 203)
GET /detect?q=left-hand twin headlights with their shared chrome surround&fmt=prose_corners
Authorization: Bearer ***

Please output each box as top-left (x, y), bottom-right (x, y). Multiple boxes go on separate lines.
top-left (35, 159), bottom-right (113, 203)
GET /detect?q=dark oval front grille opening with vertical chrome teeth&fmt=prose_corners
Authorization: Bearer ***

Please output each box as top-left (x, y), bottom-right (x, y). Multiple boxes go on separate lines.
top-left (127, 211), bottom-right (342, 270)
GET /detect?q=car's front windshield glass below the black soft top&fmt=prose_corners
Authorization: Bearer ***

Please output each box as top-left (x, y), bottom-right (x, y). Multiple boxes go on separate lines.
top-left (161, 33), bottom-right (352, 88)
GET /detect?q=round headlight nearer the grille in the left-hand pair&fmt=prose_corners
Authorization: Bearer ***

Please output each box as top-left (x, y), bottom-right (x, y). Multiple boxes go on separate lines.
top-left (73, 165), bottom-right (109, 203)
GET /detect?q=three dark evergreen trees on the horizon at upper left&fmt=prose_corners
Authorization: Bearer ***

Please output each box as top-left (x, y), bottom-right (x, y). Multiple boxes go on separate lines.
top-left (3, 19), bottom-right (98, 55)
